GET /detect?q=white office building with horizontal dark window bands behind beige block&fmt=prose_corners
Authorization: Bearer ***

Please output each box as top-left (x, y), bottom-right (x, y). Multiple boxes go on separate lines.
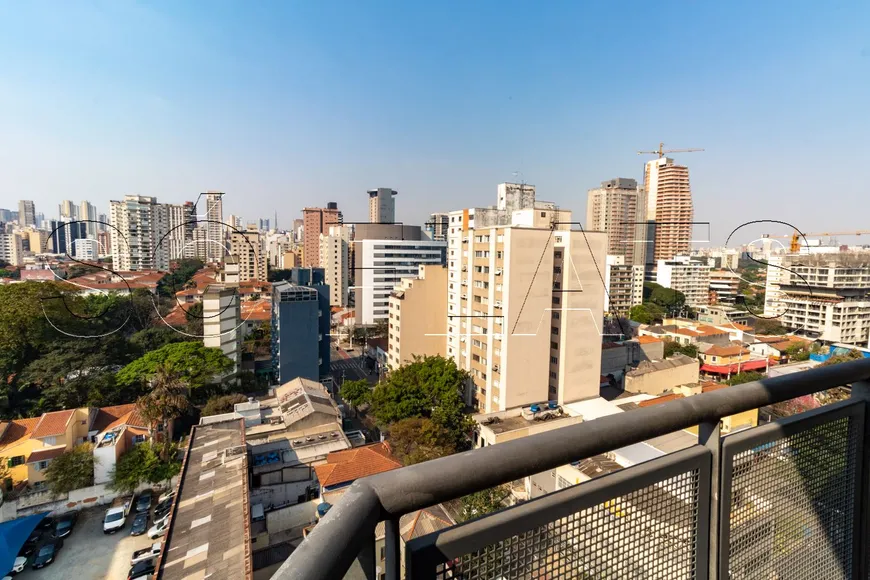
top-left (354, 237), bottom-right (447, 325)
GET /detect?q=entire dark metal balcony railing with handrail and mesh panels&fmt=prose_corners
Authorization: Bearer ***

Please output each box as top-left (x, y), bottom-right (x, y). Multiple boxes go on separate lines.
top-left (273, 360), bottom-right (870, 580)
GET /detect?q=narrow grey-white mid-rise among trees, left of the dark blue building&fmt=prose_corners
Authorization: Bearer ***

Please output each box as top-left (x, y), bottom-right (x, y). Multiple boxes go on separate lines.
top-left (202, 284), bottom-right (242, 374)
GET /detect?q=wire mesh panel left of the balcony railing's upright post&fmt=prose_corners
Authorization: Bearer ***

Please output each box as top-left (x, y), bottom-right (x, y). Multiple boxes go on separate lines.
top-left (412, 454), bottom-right (709, 580)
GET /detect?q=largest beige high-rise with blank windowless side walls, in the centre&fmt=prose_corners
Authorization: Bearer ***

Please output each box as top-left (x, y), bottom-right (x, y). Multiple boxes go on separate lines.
top-left (447, 184), bottom-right (607, 413)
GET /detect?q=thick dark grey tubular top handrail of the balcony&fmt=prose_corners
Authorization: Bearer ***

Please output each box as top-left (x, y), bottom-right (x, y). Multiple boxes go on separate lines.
top-left (273, 359), bottom-right (870, 580)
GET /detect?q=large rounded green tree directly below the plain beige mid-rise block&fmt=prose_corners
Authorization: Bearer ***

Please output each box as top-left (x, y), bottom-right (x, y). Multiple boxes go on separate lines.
top-left (372, 356), bottom-right (472, 447)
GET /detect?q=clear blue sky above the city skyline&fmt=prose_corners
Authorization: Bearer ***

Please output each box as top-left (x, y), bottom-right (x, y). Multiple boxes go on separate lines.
top-left (0, 0), bottom-right (870, 243)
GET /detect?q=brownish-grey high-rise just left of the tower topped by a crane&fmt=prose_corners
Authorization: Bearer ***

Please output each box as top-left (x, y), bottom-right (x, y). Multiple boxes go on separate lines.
top-left (586, 177), bottom-right (646, 265)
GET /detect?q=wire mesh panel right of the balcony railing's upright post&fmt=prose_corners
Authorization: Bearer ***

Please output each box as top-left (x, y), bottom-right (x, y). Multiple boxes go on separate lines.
top-left (723, 406), bottom-right (862, 580)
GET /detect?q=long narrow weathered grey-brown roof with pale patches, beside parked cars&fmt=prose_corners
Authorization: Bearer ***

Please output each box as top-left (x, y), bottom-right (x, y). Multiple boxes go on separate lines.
top-left (157, 419), bottom-right (252, 580)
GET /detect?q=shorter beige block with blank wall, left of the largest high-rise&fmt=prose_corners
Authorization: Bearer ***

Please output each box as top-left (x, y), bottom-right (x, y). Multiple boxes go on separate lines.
top-left (387, 265), bottom-right (447, 368)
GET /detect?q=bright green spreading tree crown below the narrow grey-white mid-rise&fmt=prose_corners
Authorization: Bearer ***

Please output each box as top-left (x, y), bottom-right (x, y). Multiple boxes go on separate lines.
top-left (116, 341), bottom-right (234, 389)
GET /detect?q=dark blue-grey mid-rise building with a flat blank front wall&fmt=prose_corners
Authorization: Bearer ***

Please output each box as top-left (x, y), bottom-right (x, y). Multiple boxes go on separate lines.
top-left (272, 276), bottom-right (330, 384)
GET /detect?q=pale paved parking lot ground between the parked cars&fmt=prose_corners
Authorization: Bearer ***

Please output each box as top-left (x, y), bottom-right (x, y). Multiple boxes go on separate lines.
top-left (15, 507), bottom-right (154, 580)
